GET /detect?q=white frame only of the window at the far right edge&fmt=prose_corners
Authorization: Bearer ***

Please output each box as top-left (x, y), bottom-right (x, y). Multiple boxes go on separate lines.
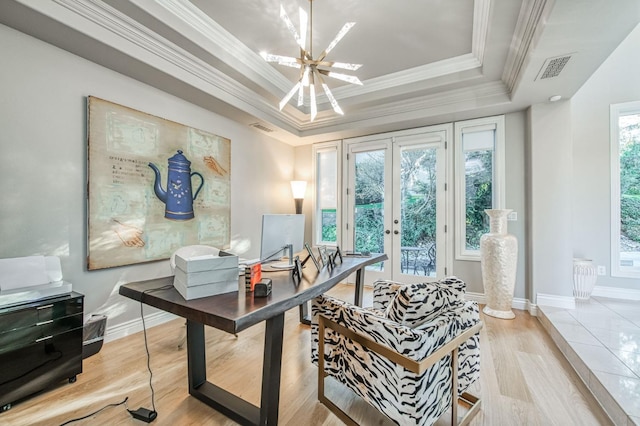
top-left (609, 101), bottom-right (640, 278)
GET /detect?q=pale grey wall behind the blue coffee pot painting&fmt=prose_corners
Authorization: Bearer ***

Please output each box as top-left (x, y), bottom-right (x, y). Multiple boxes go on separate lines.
top-left (0, 25), bottom-right (294, 327)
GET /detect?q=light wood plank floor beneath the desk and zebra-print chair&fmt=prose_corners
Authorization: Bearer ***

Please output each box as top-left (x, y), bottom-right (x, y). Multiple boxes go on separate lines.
top-left (0, 285), bottom-right (610, 426)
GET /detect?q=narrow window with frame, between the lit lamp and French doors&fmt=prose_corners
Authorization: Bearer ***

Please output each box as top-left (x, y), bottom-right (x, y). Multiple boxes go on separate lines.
top-left (313, 141), bottom-right (340, 246)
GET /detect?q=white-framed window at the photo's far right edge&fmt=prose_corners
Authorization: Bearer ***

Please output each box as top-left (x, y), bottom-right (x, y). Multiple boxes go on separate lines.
top-left (611, 102), bottom-right (640, 278)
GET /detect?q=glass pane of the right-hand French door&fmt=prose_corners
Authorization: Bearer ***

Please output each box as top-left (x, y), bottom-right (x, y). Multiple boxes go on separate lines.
top-left (400, 147), bottom-right (437, 277)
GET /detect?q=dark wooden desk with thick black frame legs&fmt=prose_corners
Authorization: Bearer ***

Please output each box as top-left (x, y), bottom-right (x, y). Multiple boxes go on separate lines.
top-left (120, 254), bottom-right (387, 425)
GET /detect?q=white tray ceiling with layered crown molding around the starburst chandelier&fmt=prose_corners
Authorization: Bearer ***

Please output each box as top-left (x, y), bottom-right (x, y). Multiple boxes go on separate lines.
top-left (0, 0), bottom-right (640, 145)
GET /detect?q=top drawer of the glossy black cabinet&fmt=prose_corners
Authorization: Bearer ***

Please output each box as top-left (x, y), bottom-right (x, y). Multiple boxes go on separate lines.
top-left (0, 295), bottom-right (83, 333)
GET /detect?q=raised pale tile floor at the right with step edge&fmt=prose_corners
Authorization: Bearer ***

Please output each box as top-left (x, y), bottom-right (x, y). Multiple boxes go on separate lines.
top-left (538, 297), bottom-right (640, 426)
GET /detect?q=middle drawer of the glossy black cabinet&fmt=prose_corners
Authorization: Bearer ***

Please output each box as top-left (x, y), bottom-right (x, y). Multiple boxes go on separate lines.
top-left (0, 314), bottom-right (83, 354)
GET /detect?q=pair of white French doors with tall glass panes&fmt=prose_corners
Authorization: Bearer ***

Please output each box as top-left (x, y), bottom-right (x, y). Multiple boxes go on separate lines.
top-left (343, 129), bottom-right (447, 283)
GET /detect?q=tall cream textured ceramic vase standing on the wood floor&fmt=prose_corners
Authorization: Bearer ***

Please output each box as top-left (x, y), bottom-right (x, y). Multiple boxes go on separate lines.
top-left (480, 209), bottom-right (518, 319)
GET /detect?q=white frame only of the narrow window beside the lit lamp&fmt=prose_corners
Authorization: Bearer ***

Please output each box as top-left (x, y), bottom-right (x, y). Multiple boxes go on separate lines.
top-left (311, 140), bottom-right (342, 247)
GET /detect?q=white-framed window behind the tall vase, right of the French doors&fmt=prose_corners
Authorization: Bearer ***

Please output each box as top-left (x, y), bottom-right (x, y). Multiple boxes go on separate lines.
top-left (455, 116), bottom-right (505, 260)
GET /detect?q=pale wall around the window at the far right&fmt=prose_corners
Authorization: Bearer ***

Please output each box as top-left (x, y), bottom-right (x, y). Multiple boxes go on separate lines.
top-left (571, 26), bottom-right (640, 290)
